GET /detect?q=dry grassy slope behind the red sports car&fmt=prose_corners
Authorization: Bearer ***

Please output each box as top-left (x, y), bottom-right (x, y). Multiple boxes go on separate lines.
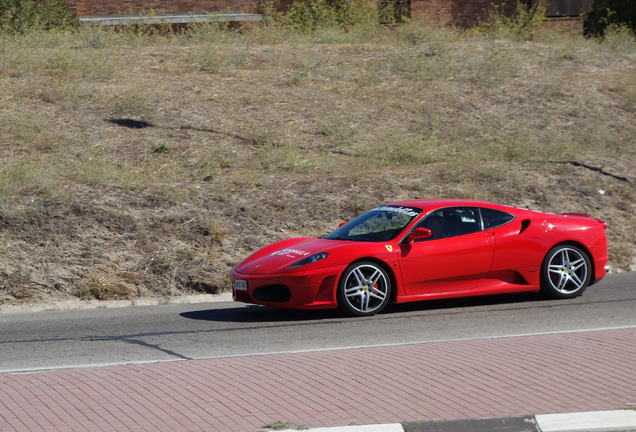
top-left (0, 18), bottom-right (636, 304)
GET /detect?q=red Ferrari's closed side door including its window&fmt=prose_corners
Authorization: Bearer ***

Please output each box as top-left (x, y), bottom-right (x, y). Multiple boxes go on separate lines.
top-left (399, 207), bottom-right (494, 295)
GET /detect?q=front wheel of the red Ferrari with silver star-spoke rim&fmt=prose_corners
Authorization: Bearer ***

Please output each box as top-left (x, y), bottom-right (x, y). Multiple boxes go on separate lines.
top-left (338, 261), bottom-right (392, 316)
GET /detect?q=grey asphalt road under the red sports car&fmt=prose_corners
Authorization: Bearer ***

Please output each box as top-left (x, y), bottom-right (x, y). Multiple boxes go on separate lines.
top-left (0, 273), bottom-right (636, 373)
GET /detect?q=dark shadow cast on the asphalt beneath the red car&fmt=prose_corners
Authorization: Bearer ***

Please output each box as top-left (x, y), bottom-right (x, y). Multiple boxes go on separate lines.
top-left (180, 292), bottom-right (546, 323)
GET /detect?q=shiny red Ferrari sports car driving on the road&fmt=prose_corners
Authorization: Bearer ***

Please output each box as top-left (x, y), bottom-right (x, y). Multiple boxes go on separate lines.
top-left (232, 199), bottom-right (608, 316)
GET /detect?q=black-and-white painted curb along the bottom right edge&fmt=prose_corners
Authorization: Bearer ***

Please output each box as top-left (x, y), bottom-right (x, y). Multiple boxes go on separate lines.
top-left (281, 409), bottom-right (636, 432)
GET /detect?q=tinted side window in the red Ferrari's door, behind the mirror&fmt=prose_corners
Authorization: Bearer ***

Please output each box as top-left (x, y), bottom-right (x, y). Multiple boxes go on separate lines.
top-left (416, 207), bottom-right (481, 241)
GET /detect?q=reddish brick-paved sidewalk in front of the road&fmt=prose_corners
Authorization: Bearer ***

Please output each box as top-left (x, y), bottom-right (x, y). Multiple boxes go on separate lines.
top-left (0, 328), bottom-right (636, 432)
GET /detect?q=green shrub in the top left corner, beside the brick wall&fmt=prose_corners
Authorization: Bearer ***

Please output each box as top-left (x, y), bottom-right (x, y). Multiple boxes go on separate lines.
top-left (0, 0), bottom-right (79, 33)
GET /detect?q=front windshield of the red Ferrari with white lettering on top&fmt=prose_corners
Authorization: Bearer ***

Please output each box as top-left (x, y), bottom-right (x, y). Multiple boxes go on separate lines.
top-left (325, 206), bottom-right (422, 242)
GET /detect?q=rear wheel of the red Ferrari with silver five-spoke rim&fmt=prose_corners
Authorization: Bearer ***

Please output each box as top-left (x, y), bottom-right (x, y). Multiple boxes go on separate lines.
top-left (541, 244), bottom-right (592, 298)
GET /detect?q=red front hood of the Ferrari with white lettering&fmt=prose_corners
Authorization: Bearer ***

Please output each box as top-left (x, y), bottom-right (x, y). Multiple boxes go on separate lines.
top-left (235, 237), bottom-right (392, 275)
